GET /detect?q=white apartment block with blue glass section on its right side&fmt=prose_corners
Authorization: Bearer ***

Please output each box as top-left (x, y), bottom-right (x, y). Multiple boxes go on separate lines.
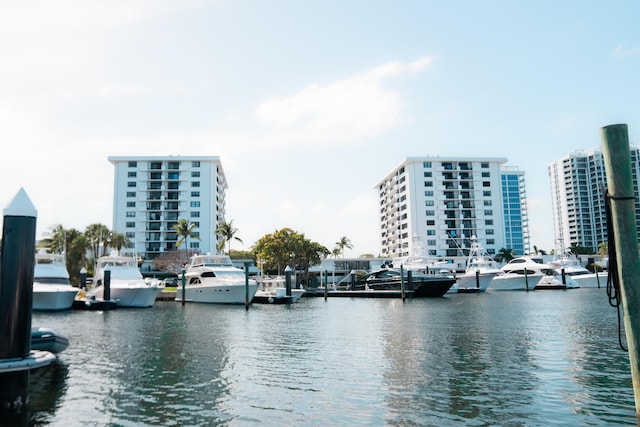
top-left (375, 157), bottom-right (529, 262)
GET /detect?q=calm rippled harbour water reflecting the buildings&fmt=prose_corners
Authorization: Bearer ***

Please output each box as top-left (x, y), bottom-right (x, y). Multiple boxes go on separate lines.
top-left (12, 289), bottom-right (636, 427)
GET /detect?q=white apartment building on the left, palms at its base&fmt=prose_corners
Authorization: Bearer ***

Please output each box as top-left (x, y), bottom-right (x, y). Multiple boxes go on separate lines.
top-left (108, 156), bottom-right (227, 268)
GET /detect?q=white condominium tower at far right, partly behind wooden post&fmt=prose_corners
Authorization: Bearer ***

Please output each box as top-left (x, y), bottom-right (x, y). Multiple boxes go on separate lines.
top-left (548, 147), bottom-right (640, 252)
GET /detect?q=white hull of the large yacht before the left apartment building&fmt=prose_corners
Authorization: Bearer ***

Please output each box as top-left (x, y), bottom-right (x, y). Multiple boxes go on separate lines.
top-left (175, 283), bottom-right (258, 304)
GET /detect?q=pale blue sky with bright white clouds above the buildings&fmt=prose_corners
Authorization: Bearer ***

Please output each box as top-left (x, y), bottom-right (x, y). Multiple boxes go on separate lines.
top-left (0, 0), bottom-right (640, 256)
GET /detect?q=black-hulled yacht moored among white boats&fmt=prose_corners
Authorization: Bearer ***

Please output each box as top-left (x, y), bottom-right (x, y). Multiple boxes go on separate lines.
top-left (354, 268), bottom-right (456, 298)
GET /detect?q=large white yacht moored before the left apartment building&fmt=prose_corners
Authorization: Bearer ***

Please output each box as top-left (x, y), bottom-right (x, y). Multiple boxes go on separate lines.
top-left (176, 254), bottom-right (258, 304)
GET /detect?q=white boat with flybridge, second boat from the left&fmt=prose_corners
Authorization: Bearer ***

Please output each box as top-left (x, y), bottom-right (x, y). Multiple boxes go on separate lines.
top-left (86, 251), bottom-right (163, 307)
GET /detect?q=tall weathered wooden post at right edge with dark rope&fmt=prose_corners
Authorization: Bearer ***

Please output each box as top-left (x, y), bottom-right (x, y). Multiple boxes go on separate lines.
top-left (601, 124), bottom-right (640, 423)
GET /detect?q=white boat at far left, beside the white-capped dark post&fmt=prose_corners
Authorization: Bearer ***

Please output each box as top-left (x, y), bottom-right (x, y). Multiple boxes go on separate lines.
top-left (32, 249), bottom-right (80, 311)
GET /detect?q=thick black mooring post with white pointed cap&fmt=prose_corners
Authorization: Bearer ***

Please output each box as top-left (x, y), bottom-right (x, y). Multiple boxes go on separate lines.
top-left (0, 189), bottom-right (37, 411)
